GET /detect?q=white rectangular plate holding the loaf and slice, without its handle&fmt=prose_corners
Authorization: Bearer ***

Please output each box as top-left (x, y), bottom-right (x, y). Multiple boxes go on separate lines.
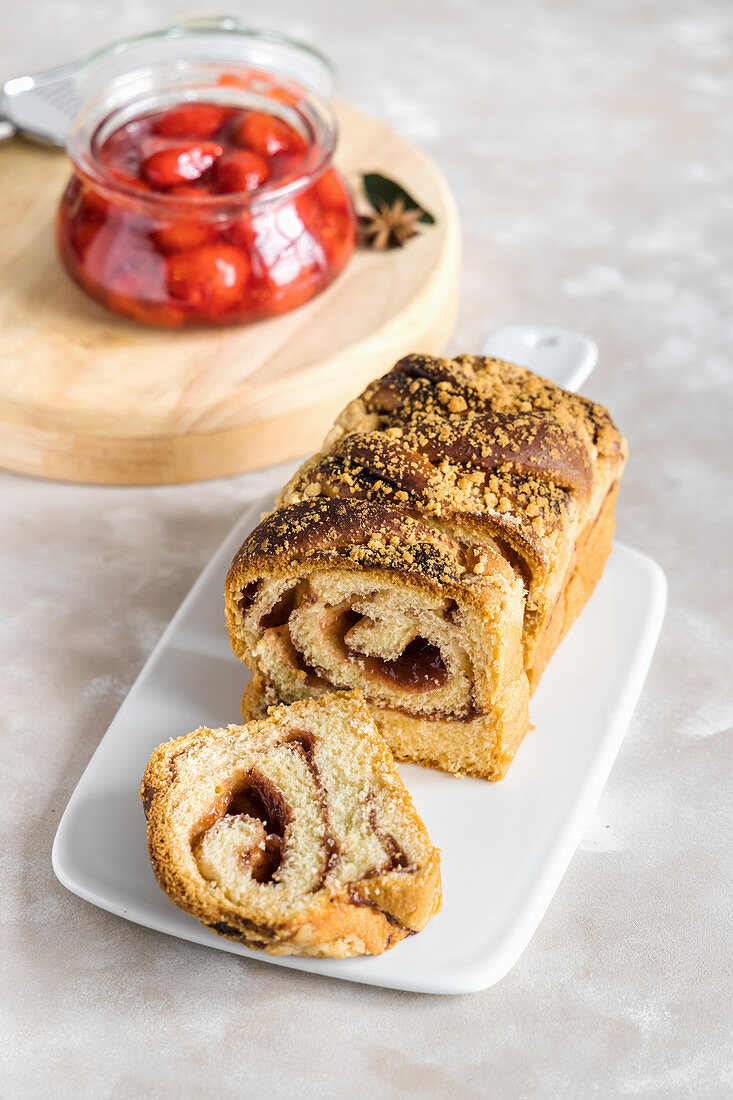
top-left (53, 502), bottom-right (666, 993)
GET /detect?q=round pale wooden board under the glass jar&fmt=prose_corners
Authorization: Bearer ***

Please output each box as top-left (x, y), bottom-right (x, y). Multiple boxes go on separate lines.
top-left (0, 103), bottom-right (460, 485)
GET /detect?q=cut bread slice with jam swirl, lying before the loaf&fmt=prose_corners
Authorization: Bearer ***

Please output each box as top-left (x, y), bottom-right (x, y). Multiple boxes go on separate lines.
top-left (141, 692), bottom-right (441, 958)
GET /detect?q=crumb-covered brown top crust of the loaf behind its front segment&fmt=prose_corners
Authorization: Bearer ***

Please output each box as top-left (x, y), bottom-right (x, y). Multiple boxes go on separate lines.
top-left (281, 355), bottom-right (624, 570)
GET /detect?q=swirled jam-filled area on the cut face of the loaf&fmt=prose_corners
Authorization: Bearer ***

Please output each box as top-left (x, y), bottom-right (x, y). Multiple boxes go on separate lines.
top-left (235, 572), bottom-right (477, 718)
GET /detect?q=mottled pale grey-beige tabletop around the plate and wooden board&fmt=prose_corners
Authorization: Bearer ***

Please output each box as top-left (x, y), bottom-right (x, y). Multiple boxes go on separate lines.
top-left (0, 0), bottom-right (733, 1098)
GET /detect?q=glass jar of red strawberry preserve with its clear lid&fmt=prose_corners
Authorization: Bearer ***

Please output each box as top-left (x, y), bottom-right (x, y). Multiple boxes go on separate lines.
top-left (57, 21), bottom-right (355, 328)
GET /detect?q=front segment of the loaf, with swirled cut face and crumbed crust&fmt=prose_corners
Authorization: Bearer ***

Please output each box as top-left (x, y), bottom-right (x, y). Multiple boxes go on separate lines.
top-left (227, 497), bottom-right (529, 779)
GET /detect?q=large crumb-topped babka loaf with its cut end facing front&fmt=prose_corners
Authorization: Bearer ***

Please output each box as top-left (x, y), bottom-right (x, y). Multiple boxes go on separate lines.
top-left (227, 355), bottom-right (626, 779)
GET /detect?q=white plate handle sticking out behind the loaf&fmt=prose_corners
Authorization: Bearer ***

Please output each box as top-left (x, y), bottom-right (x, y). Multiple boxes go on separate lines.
top-left (481, 325), bottom-right (598, 389)
